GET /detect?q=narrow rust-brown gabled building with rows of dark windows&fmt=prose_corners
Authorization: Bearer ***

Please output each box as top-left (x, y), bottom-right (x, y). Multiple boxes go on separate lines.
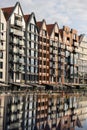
top-left (37, 20), bottom-right (49, 84)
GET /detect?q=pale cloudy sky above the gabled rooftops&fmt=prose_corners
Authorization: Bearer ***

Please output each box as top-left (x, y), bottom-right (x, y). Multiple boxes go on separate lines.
top-left (0, 0), bottom-right (87, 35)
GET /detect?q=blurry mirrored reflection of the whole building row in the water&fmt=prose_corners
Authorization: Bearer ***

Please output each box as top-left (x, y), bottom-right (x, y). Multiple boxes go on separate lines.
top-left (0, 92), bottom-right (87, 130)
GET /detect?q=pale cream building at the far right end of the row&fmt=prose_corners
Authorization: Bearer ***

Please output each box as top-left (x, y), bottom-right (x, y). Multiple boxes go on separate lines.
top-left (78, 35), bottom-right (87, 84)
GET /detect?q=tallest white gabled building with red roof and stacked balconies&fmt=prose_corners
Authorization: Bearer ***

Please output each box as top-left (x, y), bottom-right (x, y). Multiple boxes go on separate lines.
top-left (2, 2), bottom-right (25, 83)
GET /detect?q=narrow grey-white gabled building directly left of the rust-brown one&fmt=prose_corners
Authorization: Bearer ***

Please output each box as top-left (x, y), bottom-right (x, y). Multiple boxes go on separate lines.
top-left (24, 13), bottom-right (38, 83)
